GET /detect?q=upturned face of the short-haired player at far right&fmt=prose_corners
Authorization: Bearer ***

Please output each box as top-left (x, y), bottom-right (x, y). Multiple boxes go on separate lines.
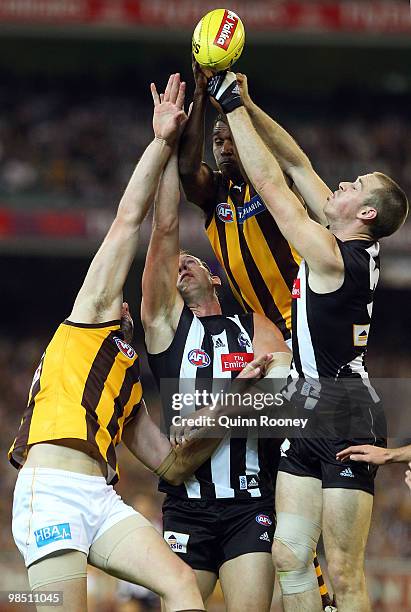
top-left (324, 174), bottom-right (381, 221)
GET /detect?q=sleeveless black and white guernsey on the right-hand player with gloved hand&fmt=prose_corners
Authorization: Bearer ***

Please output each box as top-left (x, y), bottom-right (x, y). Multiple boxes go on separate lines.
top-left (283, 239), bottom-right (386, 443)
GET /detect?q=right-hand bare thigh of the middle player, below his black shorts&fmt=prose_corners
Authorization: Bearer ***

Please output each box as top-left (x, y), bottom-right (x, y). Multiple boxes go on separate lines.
top-left (220, 552), bottom-right (274, 612)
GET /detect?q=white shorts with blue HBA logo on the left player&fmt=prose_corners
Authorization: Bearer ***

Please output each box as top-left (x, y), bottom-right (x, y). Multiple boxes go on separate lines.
top-left (12, 468), bottom-right (138, 567)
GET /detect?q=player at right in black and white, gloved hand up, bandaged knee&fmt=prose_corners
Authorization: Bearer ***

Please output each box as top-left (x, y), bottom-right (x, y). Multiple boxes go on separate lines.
top-left (209, 72), bottom-right (408, 612)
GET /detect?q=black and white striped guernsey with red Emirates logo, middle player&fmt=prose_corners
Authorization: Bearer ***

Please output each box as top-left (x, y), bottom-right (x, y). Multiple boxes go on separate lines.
top-left (148, 306), bottom-right (279, 500)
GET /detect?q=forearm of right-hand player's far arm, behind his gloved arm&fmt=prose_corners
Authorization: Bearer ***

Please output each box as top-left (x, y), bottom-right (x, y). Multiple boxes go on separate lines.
top-left (245, 101), bottom-right (311, 173)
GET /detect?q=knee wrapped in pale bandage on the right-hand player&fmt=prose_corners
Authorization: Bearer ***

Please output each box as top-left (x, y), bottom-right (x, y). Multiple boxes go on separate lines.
top-left (273, 512), bottom-right (321, 595)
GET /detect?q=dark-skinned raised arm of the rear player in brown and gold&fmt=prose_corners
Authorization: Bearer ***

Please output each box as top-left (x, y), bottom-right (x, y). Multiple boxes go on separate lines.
top-left (178, 57), bottom-right (220, 210)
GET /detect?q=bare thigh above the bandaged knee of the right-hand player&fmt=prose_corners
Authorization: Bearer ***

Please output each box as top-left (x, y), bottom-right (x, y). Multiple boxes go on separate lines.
top-left (275, 471), bottom-right (322, 522)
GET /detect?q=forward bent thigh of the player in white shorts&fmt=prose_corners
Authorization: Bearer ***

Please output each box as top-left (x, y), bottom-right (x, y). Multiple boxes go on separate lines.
top-left (89, 517), bottom-right (194, 596)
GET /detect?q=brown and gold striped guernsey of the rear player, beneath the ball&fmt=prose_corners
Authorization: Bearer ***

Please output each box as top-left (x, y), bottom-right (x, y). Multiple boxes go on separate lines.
top-left (206, 172), bottom-right (301, 340)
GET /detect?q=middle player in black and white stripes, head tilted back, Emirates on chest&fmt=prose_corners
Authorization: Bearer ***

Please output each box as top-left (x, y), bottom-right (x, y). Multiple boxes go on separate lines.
top-left (142, 81), bottom-right (291, 612)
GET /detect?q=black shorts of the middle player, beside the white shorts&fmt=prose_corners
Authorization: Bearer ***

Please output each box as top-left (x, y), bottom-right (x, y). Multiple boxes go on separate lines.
top-left (163, 495), bottom-right (275, 574)
